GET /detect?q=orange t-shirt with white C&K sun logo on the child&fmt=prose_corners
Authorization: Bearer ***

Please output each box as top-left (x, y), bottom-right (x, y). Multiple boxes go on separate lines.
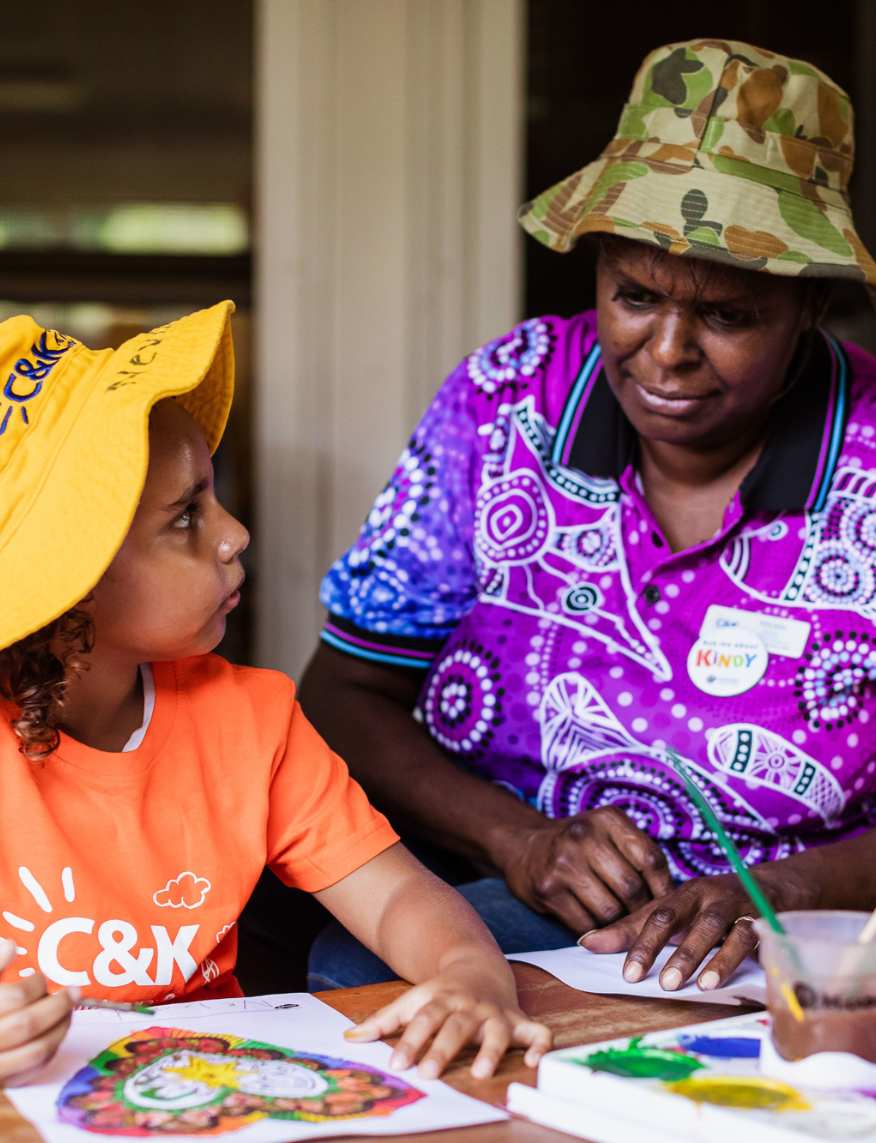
top-left (0, 655), bottom-right (398, 1002)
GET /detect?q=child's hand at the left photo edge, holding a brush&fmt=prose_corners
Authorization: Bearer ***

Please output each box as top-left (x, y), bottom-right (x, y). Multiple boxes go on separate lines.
top-left (0, 941), bottom-right (80, 1087)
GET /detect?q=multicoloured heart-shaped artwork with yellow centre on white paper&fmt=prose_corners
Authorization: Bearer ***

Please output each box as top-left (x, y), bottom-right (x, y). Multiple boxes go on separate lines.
top-left (57, 1028), bottom-right (423, 1135)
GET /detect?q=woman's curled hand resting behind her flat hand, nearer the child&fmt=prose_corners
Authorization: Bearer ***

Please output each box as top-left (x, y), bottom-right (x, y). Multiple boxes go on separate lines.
top-left (496, 806), bottom-right (674, 948)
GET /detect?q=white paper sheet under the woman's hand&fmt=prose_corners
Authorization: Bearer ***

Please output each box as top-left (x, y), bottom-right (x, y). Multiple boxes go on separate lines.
top-left (508, 944), bottom-right (766, 1004)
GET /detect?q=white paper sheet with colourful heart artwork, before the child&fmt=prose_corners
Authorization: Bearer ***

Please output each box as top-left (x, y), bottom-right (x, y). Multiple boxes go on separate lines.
top-left (7, 993), bottom-right (505, 1143)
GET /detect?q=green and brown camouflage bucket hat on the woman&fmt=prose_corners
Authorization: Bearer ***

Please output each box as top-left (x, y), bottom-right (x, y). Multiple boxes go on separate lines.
top-left (518, 40), bottom-right (876, 299)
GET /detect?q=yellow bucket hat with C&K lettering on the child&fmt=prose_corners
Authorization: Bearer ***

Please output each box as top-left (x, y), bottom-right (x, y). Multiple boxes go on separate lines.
top-left (0, 302), bottom-right (234, 647)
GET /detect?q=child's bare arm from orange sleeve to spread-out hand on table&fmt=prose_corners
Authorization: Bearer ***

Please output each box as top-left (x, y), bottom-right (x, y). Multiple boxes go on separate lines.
top-left (316, 845), bottom-right (551, 1079)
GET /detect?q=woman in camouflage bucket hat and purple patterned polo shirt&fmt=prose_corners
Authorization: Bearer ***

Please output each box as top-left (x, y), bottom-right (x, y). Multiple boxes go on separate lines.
top-left (302, 41), bottom-right (876, 989)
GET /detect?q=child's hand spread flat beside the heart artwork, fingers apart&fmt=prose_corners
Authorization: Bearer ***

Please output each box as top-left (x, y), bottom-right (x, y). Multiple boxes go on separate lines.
top-left (344, 964), bottom-right (552, 1079)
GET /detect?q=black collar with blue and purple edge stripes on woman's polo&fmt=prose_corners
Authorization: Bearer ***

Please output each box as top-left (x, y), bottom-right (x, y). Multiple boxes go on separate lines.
top-left (554, 330), bottom-right (851, 512)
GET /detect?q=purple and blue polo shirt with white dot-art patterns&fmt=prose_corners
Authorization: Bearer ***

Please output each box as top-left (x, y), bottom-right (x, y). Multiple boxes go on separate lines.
top-left (321, 312), bottom-right (876, 878)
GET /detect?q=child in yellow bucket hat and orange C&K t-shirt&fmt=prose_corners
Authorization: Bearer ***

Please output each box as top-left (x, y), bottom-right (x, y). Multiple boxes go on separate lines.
top-left (0, 302), bottom-right (550, 1082)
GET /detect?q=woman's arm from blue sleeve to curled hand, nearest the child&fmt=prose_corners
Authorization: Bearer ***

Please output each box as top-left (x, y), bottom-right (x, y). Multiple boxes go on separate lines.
top-left (298, 644), bottom-right (672, 934)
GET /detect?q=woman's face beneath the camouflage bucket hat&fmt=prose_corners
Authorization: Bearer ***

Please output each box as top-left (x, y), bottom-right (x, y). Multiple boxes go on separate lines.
top-left (597, 241), bottom-right (815, 449)
